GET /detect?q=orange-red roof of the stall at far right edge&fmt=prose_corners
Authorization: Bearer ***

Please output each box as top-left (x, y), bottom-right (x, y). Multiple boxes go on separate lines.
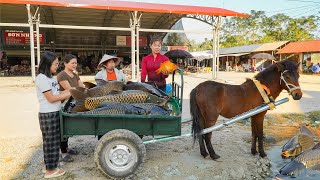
top-left (277, 40), bottom-right (320, 54)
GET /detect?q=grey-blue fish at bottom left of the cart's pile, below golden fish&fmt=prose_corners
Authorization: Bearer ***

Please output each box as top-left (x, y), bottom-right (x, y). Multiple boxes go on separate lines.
top-left (79, 102), bottom-right (150, 115)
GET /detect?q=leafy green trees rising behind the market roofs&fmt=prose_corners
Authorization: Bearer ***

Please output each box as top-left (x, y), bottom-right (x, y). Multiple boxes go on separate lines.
top-left (189, 10), bottom-right (320, 51)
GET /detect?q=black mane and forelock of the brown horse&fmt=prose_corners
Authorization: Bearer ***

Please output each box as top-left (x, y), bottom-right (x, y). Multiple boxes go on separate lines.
top-left (255, 60), bottom-right (298, 84)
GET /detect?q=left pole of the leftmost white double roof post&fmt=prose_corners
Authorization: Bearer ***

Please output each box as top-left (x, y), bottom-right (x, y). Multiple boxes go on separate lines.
top-left (26, 4), bottom-right (36, 83)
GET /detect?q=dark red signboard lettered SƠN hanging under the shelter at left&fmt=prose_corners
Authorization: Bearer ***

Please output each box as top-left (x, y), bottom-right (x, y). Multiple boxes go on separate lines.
top-left (4, 31), bottom-right (45, 45)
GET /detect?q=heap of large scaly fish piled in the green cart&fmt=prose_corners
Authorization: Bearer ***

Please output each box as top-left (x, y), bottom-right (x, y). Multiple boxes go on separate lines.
top-left (66, 80), bottom-right (171, 115)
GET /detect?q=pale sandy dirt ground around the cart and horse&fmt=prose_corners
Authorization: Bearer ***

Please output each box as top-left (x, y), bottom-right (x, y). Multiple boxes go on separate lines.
top-left (0, 72), bottom-right (320, 180)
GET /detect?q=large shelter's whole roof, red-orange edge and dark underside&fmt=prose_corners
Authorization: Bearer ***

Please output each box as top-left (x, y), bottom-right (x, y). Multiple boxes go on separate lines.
top-left (0, 0), bottom-right (247, 52)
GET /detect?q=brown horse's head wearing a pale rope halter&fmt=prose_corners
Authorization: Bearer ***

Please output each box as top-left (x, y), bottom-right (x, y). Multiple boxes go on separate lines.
top-left (276, 60), bottom-right (302, 100)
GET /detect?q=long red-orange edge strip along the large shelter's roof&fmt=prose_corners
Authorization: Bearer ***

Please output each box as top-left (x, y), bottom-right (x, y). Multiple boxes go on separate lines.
top-left (0, 0), bottom-right (249, 17)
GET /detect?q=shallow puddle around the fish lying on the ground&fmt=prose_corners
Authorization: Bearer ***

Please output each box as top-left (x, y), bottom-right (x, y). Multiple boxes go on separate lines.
top-left (267, 141), bottom-right (320, 180)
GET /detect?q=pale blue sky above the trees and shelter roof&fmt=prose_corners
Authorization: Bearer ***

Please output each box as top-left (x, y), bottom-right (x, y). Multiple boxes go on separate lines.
top-left (126, 0), bottom-right (320, 42)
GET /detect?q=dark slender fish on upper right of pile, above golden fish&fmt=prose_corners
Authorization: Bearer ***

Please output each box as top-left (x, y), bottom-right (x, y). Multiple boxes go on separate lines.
top-left (123, 81), bottom-right (168, 98)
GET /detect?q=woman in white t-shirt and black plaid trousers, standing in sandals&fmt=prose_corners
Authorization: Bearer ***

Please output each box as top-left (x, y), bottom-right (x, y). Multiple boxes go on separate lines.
top-left (36, 52), bottom-right (70, 178)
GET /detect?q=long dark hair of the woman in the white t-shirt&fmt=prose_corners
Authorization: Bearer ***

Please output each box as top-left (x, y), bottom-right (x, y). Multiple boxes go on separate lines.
top-left (38, 51), bottom-right (57, 78)
